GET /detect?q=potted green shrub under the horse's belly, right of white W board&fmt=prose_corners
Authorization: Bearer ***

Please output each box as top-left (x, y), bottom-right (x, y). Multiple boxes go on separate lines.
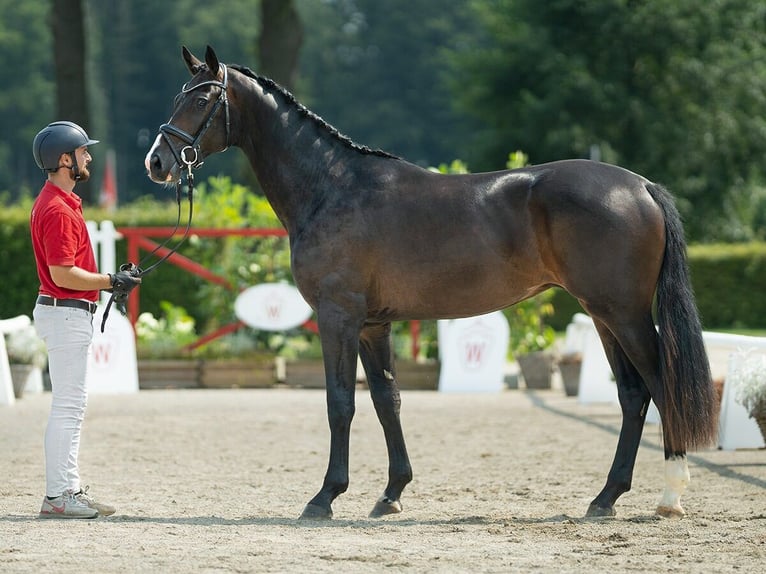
top-left (505, 289), bottom-right (556, 389)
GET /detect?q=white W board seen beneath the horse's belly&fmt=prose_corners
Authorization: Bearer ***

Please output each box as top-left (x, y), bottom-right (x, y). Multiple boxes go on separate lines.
top-left (437, 311), bottom-right (510, 393)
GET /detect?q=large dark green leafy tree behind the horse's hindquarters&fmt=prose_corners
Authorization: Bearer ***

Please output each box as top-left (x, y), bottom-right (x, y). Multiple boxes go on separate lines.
top-left (452, 0), bottom-right (766, 240)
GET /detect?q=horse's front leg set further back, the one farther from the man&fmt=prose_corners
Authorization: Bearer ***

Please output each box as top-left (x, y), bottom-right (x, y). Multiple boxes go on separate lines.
top-left (359, 323), bottom-right (412, 518)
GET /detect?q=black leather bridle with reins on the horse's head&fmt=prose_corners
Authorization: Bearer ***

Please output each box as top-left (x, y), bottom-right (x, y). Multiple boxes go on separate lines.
top-left (101, 64), bottom-right (231, 333)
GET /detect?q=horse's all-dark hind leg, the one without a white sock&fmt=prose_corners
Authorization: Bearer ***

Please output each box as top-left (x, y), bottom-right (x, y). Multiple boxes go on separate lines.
top-left (587, 317), bottom-right (656, 516)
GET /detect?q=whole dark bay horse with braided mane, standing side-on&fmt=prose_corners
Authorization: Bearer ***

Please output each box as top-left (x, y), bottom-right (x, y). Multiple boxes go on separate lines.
top-left (146, 47), bottom-right (717, 519)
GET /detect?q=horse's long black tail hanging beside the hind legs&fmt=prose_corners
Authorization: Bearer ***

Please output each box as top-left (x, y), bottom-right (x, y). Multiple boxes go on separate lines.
top-left (646, 183), bottom-right (718, 453)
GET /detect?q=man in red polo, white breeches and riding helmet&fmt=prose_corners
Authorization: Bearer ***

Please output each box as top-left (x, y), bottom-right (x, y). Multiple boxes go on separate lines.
top-left (30, 121), bottom-right (141, 518)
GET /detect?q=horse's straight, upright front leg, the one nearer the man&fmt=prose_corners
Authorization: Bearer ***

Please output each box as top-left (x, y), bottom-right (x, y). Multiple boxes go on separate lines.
top-left (301, 296), bottom-right (362, 519)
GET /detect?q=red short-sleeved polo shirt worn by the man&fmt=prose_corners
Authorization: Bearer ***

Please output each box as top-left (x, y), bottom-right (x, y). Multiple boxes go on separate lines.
top-left (30, 181), bottom-right (98, 302)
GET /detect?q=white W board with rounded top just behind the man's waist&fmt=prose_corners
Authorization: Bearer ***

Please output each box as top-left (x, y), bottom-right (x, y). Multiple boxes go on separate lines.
top-left (86, 304), bottom-right (138, 394)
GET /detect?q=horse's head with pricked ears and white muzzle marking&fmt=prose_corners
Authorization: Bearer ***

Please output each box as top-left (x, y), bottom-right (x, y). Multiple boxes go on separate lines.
top-left (144, 46), bottom-right (230, 183)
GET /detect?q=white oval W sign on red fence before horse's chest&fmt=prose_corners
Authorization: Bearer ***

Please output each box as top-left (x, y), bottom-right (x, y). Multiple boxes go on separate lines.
top-left (234, 283), bottom-right (313, 331)
